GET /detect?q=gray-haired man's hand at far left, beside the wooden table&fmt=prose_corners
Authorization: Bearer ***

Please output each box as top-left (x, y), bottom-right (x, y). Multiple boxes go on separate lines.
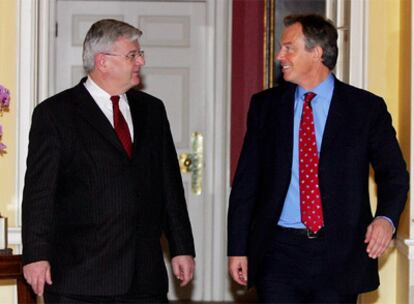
top-left (23, 261), bottom-right (52, 296)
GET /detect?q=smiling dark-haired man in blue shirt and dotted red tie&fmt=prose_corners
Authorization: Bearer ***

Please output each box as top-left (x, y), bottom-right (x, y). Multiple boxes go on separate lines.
top-left (228, 15), bottom-right (409, 303)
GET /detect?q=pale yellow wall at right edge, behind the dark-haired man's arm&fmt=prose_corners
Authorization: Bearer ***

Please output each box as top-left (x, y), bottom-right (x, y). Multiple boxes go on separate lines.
top-left (361, 0), bottom-right (411, 304)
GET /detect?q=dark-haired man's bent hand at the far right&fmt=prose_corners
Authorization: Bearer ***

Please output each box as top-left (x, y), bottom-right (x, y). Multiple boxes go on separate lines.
top-left (364, 217), bottom-right (394, 259)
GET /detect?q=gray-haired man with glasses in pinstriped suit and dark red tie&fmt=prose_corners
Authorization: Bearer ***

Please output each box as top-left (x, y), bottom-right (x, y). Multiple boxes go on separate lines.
top-left (22, 19), bottom-right (195, 303)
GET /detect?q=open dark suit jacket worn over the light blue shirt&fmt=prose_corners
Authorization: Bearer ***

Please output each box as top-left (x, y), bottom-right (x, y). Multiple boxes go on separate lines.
top-left (228, 80), bottom-right (408, 293)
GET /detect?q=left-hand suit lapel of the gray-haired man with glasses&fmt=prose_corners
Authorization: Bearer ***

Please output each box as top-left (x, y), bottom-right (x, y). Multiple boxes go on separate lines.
top-left (73, 79), bottom-right (126, 155)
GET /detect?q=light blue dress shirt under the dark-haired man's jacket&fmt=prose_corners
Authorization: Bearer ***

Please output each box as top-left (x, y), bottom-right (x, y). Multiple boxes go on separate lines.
top-left (278, 74), bottom-right (335, 228)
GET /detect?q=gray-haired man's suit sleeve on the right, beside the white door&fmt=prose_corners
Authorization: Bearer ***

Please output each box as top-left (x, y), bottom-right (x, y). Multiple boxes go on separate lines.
top-left (161, 106), bottom-right (195, 257)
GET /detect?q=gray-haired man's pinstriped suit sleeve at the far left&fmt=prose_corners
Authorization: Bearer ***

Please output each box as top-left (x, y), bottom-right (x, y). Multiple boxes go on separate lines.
top-left (22, 104), bottom-right (61, 264)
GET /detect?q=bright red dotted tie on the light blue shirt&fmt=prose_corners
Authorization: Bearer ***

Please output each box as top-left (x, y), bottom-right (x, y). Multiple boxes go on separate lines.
top-left (299, 92), bottom-right (323, 233)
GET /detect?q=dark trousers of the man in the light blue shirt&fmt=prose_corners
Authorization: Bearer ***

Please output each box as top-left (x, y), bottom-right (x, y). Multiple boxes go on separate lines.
top-left (256, 226), bottom-right (358, 304)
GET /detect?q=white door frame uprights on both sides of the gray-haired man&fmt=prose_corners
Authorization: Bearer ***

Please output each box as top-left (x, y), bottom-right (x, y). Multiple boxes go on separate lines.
top-left (15, 0), bottom-right (232, 301)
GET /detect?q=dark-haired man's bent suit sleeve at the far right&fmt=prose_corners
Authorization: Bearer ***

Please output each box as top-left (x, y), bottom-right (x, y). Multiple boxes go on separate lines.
top-left (369, 99), bottom-right (409, 227)
